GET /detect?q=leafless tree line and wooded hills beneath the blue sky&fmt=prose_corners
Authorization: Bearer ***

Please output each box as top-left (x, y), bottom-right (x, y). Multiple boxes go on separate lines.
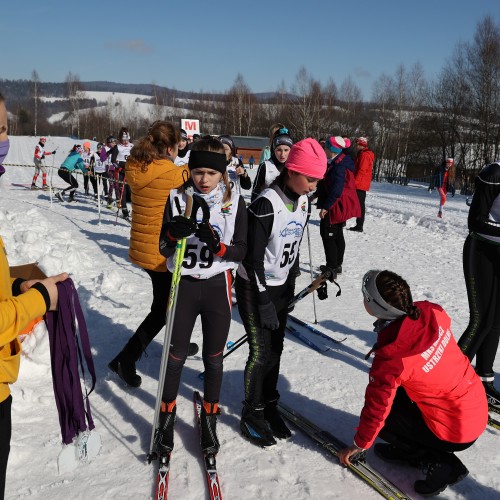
top-left (0, 16), bottom-right (500, 192)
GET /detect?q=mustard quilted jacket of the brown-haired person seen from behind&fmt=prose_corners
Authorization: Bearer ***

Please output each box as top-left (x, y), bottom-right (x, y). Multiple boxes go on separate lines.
top-left (125, 159), bottom-right (189, 272)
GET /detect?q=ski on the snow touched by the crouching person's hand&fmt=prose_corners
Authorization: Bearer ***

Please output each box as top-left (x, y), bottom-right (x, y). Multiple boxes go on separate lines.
top-left (278, 402), bottom-right (410, 500)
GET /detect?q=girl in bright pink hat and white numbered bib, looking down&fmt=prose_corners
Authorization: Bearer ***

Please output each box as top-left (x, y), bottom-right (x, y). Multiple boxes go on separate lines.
top-left (235, 139), bottom-right (327, 446)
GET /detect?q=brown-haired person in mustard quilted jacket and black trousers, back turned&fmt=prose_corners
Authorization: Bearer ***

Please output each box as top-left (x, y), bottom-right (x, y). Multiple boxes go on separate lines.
top-left (108, 121), bottom-right (192, 387)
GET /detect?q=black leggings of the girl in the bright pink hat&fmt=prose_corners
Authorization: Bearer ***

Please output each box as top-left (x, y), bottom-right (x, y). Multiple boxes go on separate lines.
top-left (235, 275), bottom-right (293, 406)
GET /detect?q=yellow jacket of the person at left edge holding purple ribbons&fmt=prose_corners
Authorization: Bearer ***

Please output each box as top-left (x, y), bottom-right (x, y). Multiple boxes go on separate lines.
top-left (0, 237), bottom-right (47, 403)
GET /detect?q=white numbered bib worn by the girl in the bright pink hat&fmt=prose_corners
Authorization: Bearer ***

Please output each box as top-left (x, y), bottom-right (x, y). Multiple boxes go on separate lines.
top-left (261, 189), bottom-right (308, 286)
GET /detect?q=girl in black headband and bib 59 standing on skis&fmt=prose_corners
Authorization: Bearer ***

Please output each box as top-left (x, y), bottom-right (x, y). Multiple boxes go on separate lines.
top-left (155, 136), bottom-right (247, 455)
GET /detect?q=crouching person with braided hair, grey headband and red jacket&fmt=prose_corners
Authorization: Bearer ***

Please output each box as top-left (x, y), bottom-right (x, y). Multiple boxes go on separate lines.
top-left (338, 271), bottom-right (488, 496)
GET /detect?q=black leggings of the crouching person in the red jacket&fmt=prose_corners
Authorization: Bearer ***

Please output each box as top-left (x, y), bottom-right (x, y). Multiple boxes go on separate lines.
top-left (379, 387), bottom-right (475, 460)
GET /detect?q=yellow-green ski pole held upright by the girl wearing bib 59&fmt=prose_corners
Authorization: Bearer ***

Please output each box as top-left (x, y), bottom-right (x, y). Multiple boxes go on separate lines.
top-left (148, 187), bottom-right (194, 463)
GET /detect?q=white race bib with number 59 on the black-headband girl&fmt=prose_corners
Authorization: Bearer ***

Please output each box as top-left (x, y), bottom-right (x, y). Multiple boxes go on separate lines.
top-left (167, 189), bottom-right (239, 279)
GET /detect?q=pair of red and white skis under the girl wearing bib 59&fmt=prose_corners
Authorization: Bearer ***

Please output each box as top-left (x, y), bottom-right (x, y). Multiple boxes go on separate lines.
top-left (156, 391), bottom-right (222, 500)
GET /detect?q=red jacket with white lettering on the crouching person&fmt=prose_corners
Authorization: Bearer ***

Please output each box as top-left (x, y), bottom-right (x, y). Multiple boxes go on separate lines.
top-left (354, 301), bottom-right (488, 449)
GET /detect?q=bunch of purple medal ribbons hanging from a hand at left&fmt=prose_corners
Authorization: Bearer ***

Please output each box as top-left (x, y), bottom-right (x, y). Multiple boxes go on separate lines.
top-left (45, 278), bottom-right (96, 444)
